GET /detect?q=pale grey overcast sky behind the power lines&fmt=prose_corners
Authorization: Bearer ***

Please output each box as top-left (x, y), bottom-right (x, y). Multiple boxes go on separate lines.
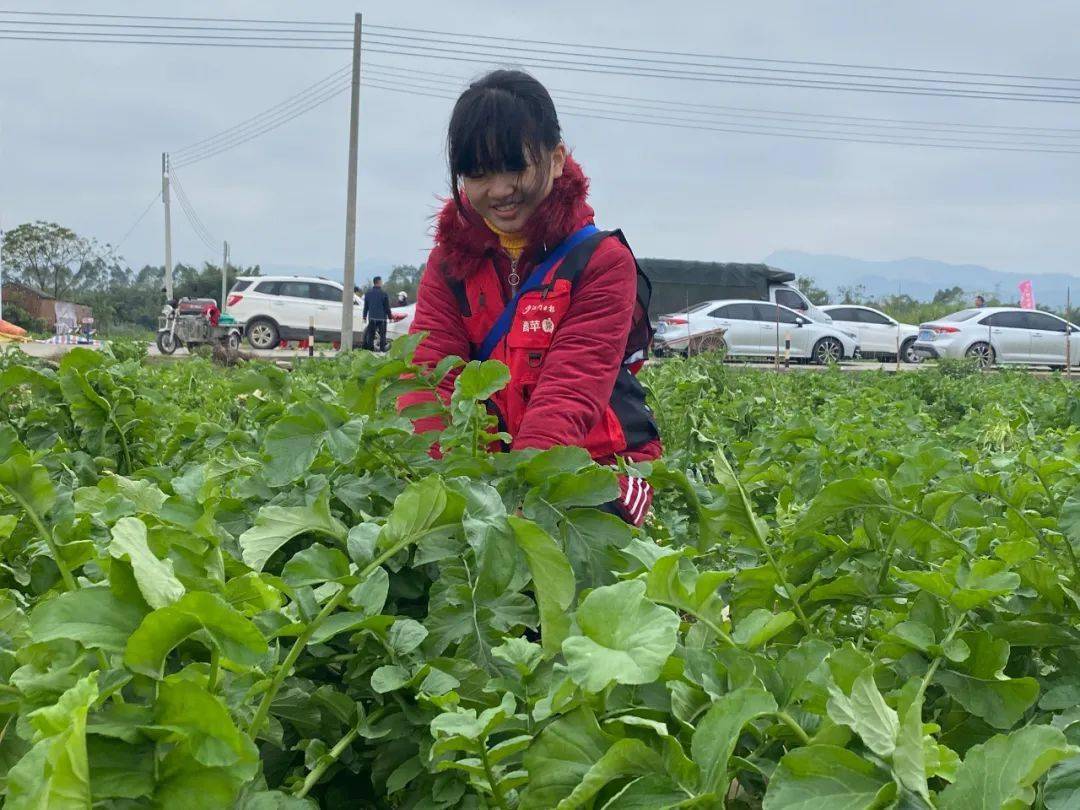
top-left (0, 0), bottom-right (1080, 274)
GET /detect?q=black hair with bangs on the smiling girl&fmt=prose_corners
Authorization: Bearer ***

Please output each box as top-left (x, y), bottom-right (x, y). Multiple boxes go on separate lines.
top-left (446, 70), bottom-right (563, 208)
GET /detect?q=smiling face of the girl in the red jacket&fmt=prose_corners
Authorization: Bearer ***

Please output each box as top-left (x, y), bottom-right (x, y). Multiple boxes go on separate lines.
top-left (461, 144), bottom-right (566, 233)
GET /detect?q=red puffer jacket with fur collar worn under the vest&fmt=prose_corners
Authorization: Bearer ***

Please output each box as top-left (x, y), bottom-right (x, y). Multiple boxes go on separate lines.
top-left (399, 158), bottom-right (662, 462)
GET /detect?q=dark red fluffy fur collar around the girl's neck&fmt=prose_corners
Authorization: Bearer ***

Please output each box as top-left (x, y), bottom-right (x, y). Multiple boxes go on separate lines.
top-left (435, 156), bottom-right (593, 279)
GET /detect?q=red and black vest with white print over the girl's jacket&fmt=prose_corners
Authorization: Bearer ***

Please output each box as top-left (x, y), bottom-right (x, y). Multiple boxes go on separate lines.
top-left (450, 231), bottom-right (659, 459)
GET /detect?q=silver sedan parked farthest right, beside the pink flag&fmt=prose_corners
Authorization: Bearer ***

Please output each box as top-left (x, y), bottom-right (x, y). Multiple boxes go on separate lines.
top-left (915, 307), bottom-right (1080, 368)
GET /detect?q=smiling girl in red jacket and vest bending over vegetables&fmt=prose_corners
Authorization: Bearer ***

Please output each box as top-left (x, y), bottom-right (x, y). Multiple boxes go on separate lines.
top-left (403, 70), bottom-right (661, 525)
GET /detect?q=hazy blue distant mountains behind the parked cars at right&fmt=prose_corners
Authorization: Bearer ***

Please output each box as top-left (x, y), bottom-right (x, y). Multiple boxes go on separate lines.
top-left (765, 251), bottom-right (1080, 307)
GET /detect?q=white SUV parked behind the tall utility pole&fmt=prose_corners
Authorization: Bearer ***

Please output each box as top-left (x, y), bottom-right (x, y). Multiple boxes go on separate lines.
top-left (226, 275), bottom-right (364, 349)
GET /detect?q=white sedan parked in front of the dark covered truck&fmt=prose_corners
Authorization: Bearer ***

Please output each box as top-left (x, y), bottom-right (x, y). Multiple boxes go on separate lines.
top-left (657, 299), bottom-right (859, 364)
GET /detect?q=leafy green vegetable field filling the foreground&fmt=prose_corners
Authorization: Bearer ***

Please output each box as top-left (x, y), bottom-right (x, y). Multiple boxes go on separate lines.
top-left (0, 340), bottom-right (1080, 810)
